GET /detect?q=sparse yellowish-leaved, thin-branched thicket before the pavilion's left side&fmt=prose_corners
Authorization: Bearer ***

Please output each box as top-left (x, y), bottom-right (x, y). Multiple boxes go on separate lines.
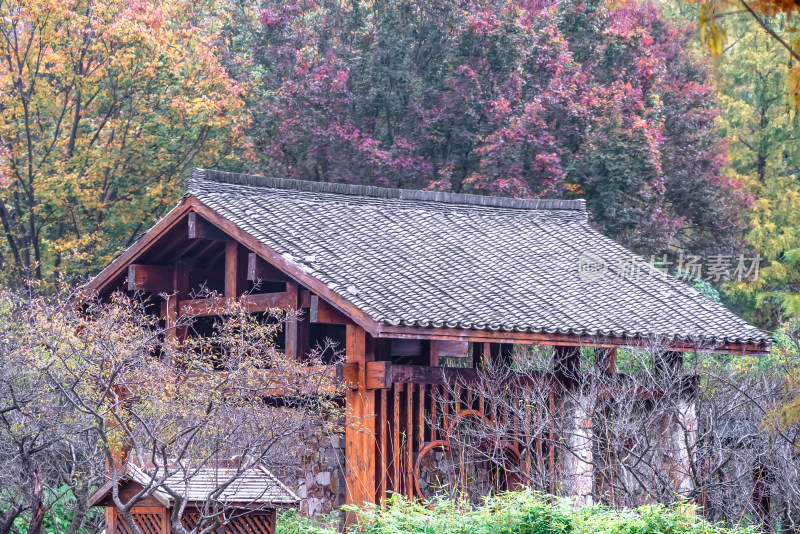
top-left (0, 292), bottom-right (343, 534)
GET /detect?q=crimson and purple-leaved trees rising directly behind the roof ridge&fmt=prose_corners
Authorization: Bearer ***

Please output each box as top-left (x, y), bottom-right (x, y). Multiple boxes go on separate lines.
top-left (225, 0), bottom-right (746, 260)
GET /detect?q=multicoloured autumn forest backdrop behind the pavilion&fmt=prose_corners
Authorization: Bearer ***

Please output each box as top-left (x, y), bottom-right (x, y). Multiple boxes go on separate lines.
top-left (0, 0), bottom-right (800, 532)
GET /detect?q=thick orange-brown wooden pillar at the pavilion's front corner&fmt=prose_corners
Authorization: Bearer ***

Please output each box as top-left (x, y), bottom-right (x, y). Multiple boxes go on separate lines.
top-left (345, 324), bottom-right (376, 523)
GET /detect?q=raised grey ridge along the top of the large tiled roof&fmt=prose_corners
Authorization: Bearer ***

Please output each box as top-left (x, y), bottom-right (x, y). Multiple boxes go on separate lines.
top-left (184, 168), bottom-right (586, 212)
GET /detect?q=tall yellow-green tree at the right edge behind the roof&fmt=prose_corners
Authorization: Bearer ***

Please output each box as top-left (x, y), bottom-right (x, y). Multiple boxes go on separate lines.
top-left (700, 15), bottom-right (800, 329)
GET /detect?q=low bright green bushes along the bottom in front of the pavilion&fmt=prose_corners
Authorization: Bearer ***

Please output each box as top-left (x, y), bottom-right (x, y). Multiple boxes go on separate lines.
top-left (278, 491), bottom-right (753, 534)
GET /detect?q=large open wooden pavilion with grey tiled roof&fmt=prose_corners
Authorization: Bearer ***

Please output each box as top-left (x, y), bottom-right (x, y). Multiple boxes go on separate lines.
top-left (88, 169), bottom-right (770, 503)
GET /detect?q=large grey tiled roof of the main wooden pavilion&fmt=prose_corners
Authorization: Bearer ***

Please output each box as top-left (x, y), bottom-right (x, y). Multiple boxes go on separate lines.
top-left (186, 169), bottom-right (770, 350)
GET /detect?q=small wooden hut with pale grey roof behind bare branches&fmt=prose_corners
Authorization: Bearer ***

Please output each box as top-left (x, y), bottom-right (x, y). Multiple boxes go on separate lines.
top-left (89, 464), bottom-right (298, 534)
